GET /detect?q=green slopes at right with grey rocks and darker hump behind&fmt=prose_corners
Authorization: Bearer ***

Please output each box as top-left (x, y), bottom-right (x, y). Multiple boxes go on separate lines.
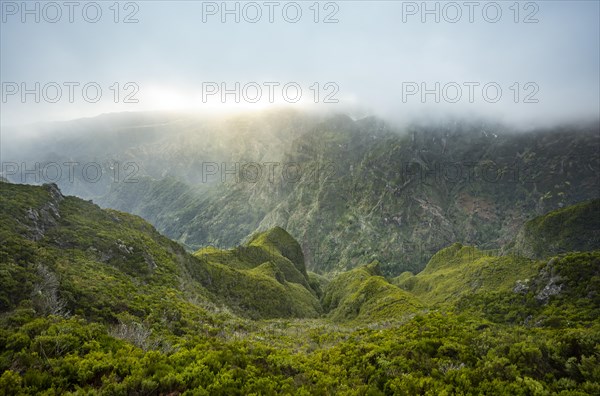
top-left (392, 200), bottom-right (600, 327)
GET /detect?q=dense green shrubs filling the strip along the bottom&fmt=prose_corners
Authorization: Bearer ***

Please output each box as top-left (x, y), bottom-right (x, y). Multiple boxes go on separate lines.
top-left (0, 313), bottom-right (600, 395)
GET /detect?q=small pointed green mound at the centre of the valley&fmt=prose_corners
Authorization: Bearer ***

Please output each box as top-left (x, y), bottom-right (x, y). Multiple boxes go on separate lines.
top-left (192, 228), bottom-right (321, 318)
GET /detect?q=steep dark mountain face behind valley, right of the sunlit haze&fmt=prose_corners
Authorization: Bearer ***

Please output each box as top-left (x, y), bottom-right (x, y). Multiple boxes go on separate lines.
top-left (254, 119), bottom-right (600, 275)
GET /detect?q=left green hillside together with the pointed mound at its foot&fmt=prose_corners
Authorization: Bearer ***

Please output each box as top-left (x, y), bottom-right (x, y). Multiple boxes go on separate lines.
top-left (0, 182), bottom-right (320, 331)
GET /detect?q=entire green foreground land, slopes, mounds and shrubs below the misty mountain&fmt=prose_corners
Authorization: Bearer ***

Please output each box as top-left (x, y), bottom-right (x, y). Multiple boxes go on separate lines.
top-left (0, 182), bottom-right (600, 396)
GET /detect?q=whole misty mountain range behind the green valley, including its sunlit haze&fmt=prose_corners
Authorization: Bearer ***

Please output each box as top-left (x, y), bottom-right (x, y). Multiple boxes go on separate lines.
top-left (3, 111), bottom-right (600, 276)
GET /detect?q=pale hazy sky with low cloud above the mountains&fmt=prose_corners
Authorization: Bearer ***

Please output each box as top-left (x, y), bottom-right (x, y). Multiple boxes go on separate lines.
top-left (0, 1), bottom-right (600, 126)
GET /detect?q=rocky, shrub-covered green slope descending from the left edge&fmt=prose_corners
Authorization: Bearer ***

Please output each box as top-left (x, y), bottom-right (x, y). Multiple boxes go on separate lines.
top-left (0, 182), bottom-right (231, 340)
